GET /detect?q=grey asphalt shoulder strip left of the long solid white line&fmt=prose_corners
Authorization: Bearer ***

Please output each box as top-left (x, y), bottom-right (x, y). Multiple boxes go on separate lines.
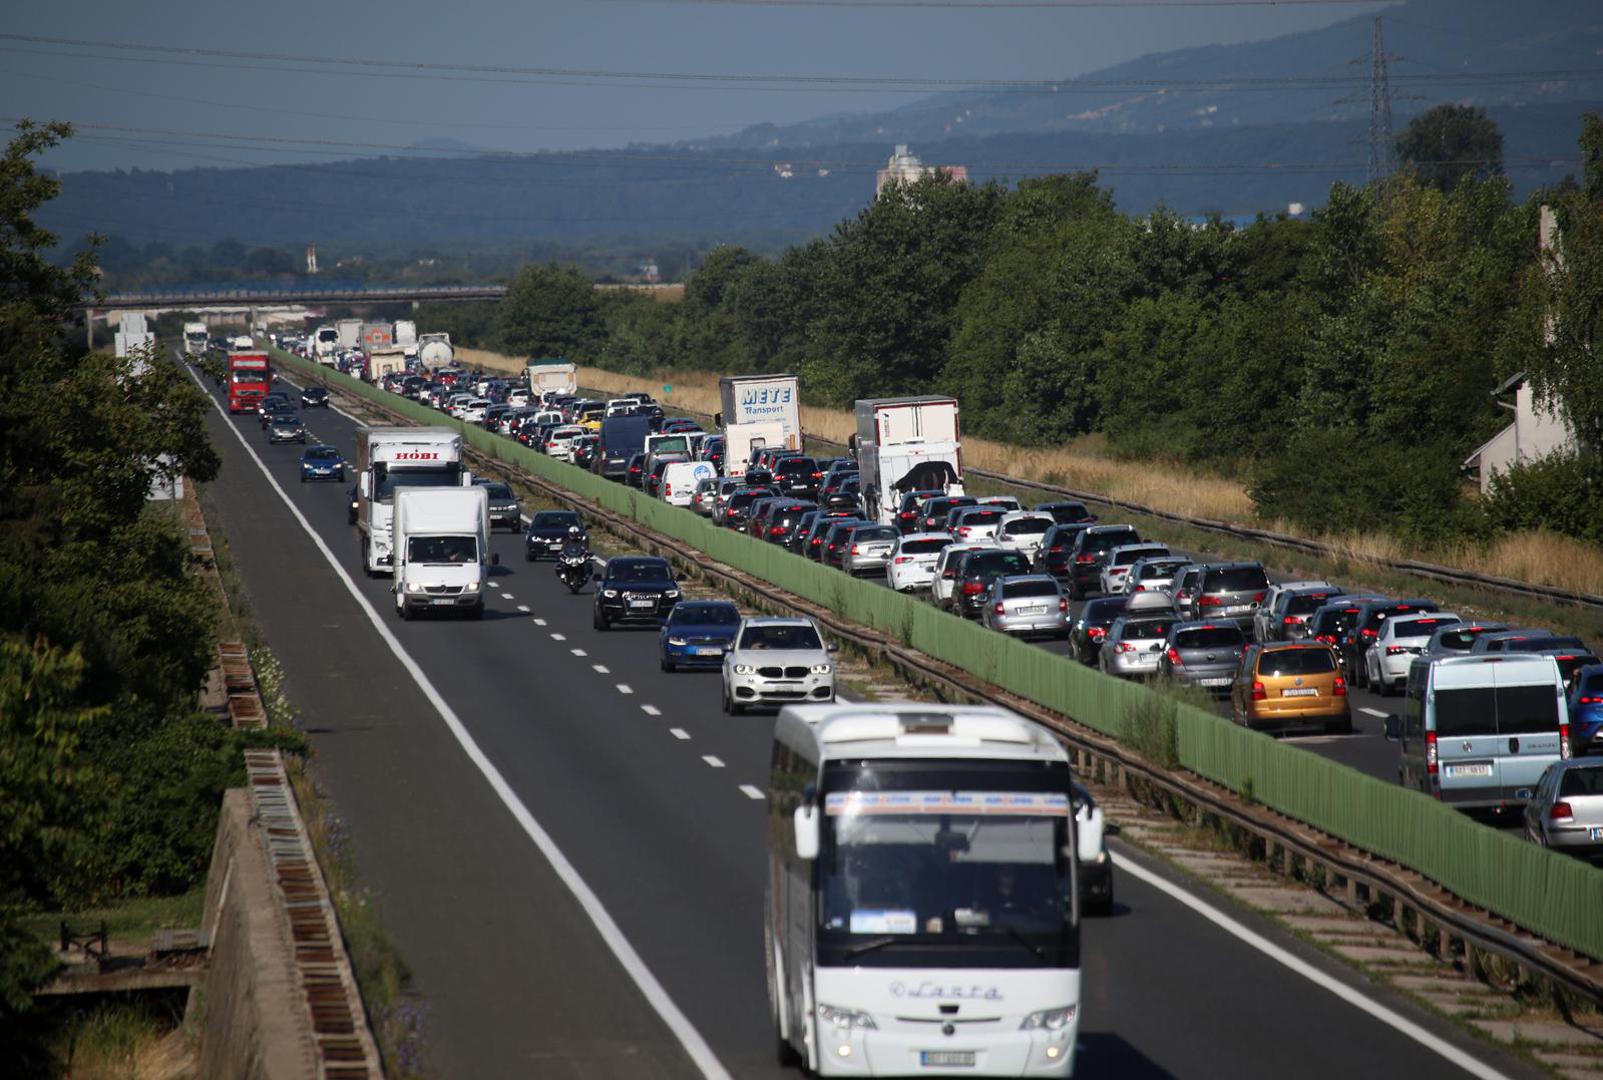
top-left (197, 397), bottom-right (694, 1077)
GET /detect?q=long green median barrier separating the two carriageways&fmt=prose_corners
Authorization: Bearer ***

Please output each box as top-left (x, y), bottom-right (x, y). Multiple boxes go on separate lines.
top-left (274, 349), bottom-right (1603, 960)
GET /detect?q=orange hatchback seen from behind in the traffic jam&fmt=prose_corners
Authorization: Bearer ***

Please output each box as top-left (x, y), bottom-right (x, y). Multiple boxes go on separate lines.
top-left (1230, 641), bottom-right (1353, 734)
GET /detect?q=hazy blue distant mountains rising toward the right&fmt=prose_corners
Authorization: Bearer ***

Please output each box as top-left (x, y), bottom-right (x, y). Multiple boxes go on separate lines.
top-left (40, 0), bottom-right (1603, 252)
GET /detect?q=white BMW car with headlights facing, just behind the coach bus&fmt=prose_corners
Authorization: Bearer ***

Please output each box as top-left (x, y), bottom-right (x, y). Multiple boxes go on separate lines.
top-left (723, 619), bottom-right (835, 716)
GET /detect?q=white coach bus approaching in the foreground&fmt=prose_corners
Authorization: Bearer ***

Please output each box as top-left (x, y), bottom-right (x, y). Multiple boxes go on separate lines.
top-left (765, 702), bottom-right (1101, 1077)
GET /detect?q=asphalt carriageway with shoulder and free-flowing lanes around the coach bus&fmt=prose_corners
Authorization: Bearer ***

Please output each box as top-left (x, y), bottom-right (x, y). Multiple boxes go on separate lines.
top-left (187, 362), bottom-right (1523, 1078)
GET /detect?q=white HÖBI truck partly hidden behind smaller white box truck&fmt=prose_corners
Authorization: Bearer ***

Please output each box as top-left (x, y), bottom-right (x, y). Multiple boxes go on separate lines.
top-left (356, 428), bottom-right (473, 577)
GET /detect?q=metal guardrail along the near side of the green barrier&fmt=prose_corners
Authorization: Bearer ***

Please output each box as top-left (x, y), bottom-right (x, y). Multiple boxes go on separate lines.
top-left (288, 352), bottom-right (1603, 1001)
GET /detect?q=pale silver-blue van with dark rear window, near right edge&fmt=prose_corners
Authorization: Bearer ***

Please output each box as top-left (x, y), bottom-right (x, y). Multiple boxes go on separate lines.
top-left (1387, 654), bottom-right (1569, 811)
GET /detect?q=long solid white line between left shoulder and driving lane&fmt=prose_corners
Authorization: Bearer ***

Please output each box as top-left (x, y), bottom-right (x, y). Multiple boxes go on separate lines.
top-left (189, 363), bottom-right (729, 1080)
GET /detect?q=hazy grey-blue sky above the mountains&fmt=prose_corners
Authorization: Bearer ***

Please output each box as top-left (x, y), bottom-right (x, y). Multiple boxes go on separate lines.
top-left (0, 0), bottom-right (1382, 170)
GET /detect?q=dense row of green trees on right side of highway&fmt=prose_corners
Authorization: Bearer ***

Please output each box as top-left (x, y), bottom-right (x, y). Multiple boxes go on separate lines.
top-left (420, 106), bottom-right (1603, 542)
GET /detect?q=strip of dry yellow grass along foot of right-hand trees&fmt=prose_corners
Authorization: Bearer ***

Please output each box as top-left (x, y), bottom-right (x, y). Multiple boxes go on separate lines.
top-left (457, 349), bottom-right (1603, 594)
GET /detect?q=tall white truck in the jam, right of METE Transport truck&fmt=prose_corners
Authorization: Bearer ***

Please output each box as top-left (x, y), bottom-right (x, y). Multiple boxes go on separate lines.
top-left (853, 394), bottom-right (963, 526)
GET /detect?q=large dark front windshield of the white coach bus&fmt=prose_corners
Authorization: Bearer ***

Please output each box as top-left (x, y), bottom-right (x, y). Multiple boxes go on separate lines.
top-left (818, 778), bottom-right (1077, 966)
